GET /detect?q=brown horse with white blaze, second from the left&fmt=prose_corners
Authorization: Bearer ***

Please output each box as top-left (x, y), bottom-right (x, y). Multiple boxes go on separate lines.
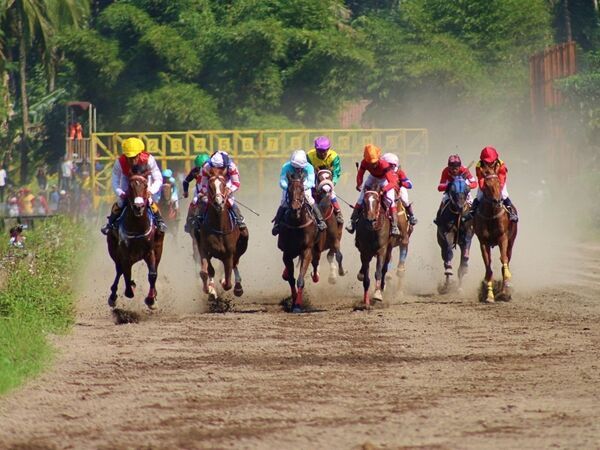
top-left (193, 168), bottom-right (249, 300)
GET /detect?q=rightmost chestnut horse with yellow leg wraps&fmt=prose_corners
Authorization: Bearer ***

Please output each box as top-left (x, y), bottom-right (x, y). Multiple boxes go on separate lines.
top-left (473, 165), bottom-right (517, 303)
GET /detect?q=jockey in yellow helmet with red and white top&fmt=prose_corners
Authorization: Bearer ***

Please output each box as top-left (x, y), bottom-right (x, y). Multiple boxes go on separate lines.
top-left (100, 137), bottom-right (167, 234)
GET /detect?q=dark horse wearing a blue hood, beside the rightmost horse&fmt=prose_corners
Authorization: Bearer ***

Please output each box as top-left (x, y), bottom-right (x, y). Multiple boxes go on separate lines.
top-left (435, 176), bottom-right (473, 294)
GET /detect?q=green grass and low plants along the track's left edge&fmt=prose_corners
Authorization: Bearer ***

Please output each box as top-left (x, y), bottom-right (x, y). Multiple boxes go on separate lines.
top-left (0, 218), bottom-right (86, 394)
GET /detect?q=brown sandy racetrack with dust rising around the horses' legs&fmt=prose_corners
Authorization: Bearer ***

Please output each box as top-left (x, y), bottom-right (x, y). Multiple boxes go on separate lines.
top-left (0, 185), bottom-right (600, 450)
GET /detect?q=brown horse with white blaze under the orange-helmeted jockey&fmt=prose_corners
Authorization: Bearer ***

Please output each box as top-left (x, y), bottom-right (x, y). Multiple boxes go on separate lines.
top-left (354, 190), bottom-right (392, 309)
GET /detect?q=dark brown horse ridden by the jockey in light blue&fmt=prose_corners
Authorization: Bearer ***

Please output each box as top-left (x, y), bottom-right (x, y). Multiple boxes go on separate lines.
top-left (277, 174), bottom-right (318, 313)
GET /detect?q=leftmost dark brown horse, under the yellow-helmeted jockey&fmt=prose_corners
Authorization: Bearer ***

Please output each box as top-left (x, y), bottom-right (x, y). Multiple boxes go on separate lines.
top-left (106, 175), bottom-right (165, 309)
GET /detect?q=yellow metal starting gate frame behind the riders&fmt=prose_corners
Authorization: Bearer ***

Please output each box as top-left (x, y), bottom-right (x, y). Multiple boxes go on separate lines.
top-left (91, 128), bottom-right (429, 205)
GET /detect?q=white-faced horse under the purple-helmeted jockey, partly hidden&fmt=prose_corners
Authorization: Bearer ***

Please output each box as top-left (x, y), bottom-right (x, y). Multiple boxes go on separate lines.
top-left (312, 170), bottom-right (346, 284)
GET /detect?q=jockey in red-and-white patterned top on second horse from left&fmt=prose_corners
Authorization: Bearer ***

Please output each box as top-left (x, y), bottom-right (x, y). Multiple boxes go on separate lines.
top-left (194, 150), bottom-right (246, 230)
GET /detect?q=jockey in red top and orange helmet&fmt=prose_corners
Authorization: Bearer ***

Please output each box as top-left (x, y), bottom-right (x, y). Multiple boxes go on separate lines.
top-left (346, 144), bottom-right (400, 236)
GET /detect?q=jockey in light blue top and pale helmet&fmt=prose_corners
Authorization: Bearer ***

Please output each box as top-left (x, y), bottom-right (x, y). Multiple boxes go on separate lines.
top-left (271, 150), bottom-right (327, 236)
